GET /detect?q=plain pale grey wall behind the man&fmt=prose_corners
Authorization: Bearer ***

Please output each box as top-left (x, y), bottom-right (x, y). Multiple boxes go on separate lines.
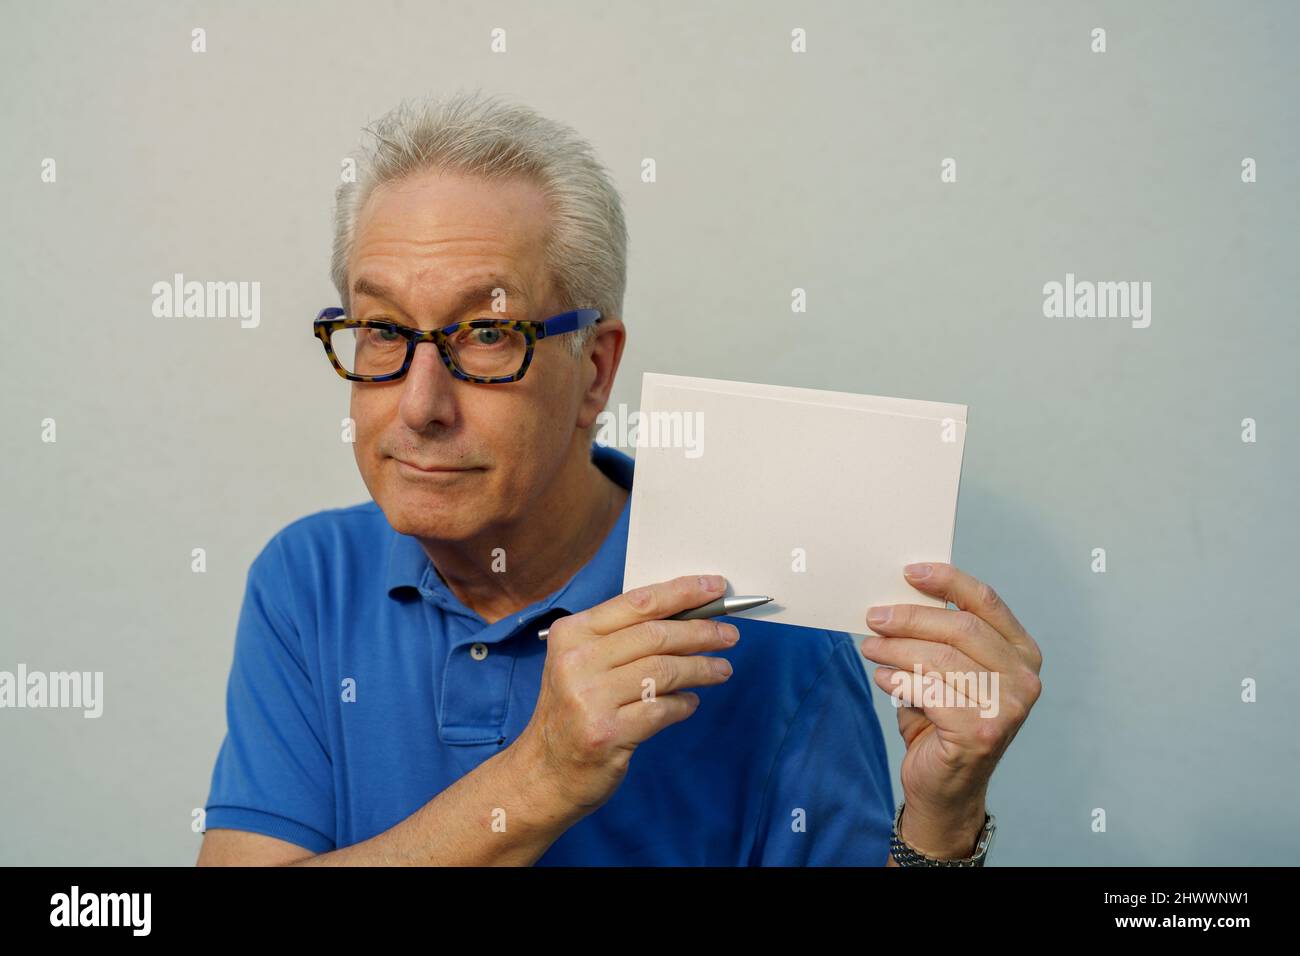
top-left (0, 0), bottom-right (1300, 864)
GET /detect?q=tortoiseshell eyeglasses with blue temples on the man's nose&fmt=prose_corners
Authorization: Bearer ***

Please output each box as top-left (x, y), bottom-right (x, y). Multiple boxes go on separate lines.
top-left (312, 308), bottom-right (602, 385)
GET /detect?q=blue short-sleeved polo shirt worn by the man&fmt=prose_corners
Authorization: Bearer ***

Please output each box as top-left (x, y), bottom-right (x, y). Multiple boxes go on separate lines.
top-left (207, 445), bottom-right (893, 866)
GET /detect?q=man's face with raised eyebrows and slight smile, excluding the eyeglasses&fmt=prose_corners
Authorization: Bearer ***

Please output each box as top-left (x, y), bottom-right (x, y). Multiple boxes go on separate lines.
top-left (348, 167), bottom-right (598, 540)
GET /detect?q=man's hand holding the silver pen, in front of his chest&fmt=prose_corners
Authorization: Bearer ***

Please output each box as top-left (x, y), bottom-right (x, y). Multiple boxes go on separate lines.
top-left (515, 575), bottom-right (740, 817)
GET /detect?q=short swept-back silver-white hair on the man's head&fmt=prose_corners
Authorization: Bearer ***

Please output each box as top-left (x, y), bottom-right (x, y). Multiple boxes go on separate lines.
top-left (330, 91), bottom-right (628, 356)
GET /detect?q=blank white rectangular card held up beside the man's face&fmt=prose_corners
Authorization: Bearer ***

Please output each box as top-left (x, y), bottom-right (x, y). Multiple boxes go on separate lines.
top-left (623, 372), bottom-right (966, 635)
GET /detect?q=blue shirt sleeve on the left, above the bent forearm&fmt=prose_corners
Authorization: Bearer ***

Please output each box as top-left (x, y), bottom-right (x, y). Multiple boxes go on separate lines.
top-left (205, 536), bottom-right (335, 853)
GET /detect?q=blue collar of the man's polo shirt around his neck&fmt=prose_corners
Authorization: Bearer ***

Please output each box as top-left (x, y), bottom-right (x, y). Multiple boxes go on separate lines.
top-left (387, 442), bottom-right (636, 617)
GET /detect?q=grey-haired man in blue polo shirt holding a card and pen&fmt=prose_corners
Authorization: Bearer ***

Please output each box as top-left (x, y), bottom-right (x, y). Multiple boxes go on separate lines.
top-left (199, 89), bottom-right (1041, 865)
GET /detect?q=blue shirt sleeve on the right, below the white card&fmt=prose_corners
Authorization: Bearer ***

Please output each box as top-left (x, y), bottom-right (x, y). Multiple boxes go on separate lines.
top-left (750, 635), bottom-right (893, 866)
